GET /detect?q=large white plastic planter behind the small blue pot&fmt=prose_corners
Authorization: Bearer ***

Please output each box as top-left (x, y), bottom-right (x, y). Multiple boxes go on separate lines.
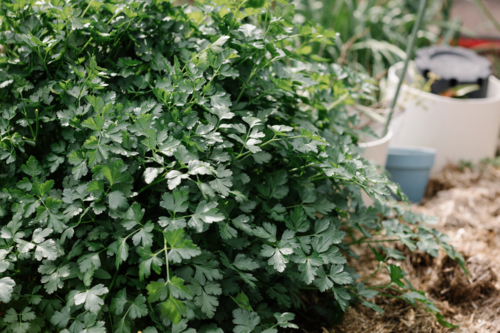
top-left (386, 63), bottom-right (500, 174)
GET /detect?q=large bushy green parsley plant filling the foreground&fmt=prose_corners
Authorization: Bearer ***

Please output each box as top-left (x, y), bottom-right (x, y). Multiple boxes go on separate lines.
top-left (0, 0), bottom-right (461, 333)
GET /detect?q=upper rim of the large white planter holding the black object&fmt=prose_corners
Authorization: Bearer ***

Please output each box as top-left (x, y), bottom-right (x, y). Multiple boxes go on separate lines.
top-left (387, 61), bottom-right (500, 104)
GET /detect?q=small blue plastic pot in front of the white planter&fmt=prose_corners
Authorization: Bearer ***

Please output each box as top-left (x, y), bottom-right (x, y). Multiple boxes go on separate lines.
top-left (386, 147), bottom-right (436, 203)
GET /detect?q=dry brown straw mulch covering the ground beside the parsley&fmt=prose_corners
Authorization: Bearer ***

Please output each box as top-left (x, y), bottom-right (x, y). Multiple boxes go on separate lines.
top-left (294, 165), bottom-right (500, 333)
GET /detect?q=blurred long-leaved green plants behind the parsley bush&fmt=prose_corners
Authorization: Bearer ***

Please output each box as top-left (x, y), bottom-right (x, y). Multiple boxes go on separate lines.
top-left (295, 0), bottom-right (474, 105)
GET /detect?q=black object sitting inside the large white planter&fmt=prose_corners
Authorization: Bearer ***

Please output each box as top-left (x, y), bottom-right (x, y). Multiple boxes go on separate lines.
top-left (415, 45), bottom-right (491, 98)
